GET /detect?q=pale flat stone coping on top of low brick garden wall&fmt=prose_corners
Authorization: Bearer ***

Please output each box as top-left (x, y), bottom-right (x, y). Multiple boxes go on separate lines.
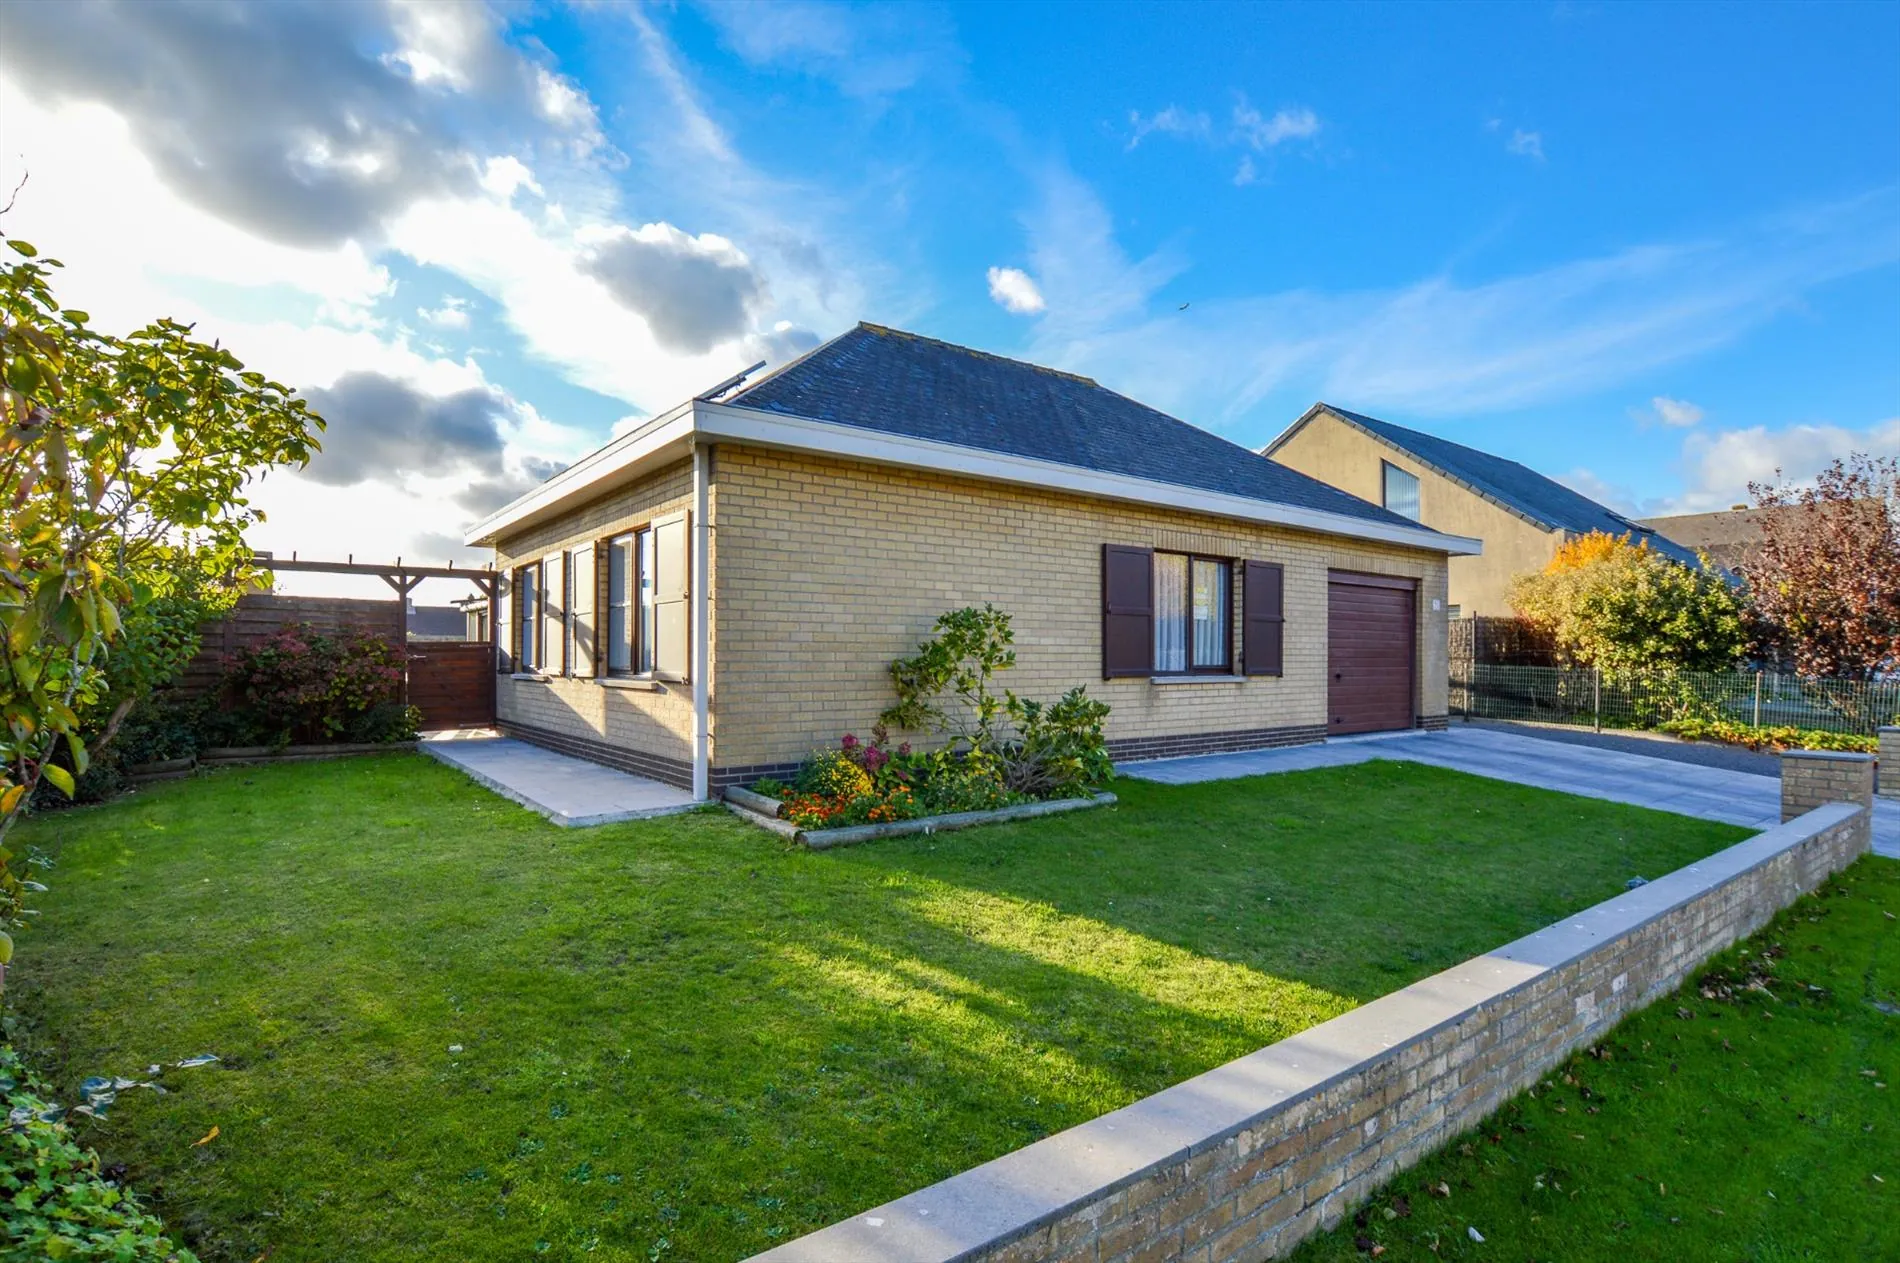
top-left (754, 803), bottom-right (1862, 1263)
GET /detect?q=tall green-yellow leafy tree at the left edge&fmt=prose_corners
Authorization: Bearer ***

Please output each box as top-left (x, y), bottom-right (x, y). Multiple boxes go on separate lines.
top-left (0, 234), bottom-right (323, 930)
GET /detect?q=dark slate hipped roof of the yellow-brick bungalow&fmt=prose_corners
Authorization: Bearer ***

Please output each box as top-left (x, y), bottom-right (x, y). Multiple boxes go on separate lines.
top-left (720, 325), bottom-right (1423, 530)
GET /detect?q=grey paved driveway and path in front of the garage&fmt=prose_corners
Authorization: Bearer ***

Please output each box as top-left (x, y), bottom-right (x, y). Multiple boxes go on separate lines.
top-left (1117, 726), bottom-right (1900, 858)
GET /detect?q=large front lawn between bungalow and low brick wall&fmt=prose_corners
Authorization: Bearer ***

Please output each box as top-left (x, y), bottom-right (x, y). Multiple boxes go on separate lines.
top-left (10, 756), bottom-right (1748, 1263)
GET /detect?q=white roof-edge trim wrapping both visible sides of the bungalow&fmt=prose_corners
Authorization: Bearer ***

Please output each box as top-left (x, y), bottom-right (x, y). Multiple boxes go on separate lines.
top-left (464, 401), bottom-right (1484, 556)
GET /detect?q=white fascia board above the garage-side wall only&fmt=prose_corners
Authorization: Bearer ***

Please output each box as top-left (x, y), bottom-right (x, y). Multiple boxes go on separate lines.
top-left (694, 403), bottom-right (1484, 556)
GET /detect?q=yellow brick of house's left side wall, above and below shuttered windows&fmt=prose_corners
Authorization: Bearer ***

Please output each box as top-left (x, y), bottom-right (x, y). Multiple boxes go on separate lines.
top-left (496, 460), bottom-right (716, 763)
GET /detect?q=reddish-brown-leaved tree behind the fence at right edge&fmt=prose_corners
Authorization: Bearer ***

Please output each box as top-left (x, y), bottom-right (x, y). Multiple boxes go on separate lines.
top-left (1742, 452), bottom-right (1900, 680)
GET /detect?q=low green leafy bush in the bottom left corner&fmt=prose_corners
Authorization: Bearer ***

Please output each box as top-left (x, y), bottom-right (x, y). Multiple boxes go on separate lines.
top-left (0, 1045), bottom-right (198, 1263)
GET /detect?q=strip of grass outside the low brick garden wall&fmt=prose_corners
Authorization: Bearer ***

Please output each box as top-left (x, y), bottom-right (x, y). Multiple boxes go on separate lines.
top-left (1296, 858), bottom-right (1900, 1263)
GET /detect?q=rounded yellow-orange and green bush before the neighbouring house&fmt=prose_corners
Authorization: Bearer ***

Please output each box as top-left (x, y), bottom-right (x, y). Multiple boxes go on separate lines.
top-left (1511, 532), bottom-right (1746, 670)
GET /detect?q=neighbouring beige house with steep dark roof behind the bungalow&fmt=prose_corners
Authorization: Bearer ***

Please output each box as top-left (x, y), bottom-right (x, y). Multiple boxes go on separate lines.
top-left (1262, 403), bottom-right (1697, 617)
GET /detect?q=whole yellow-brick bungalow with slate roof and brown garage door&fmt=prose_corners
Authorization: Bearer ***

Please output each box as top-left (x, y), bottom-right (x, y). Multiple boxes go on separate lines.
top-left (467, 325), bottom-right (1480, 796)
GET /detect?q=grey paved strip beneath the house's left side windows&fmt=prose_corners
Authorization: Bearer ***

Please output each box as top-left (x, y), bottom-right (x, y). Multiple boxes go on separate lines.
top-left (418, 727), bottom-right (695, 826)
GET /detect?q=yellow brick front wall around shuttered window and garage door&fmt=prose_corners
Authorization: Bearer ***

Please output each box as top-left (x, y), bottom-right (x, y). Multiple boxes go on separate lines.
top-left (713, 444), bottom-right (1446, 765)
